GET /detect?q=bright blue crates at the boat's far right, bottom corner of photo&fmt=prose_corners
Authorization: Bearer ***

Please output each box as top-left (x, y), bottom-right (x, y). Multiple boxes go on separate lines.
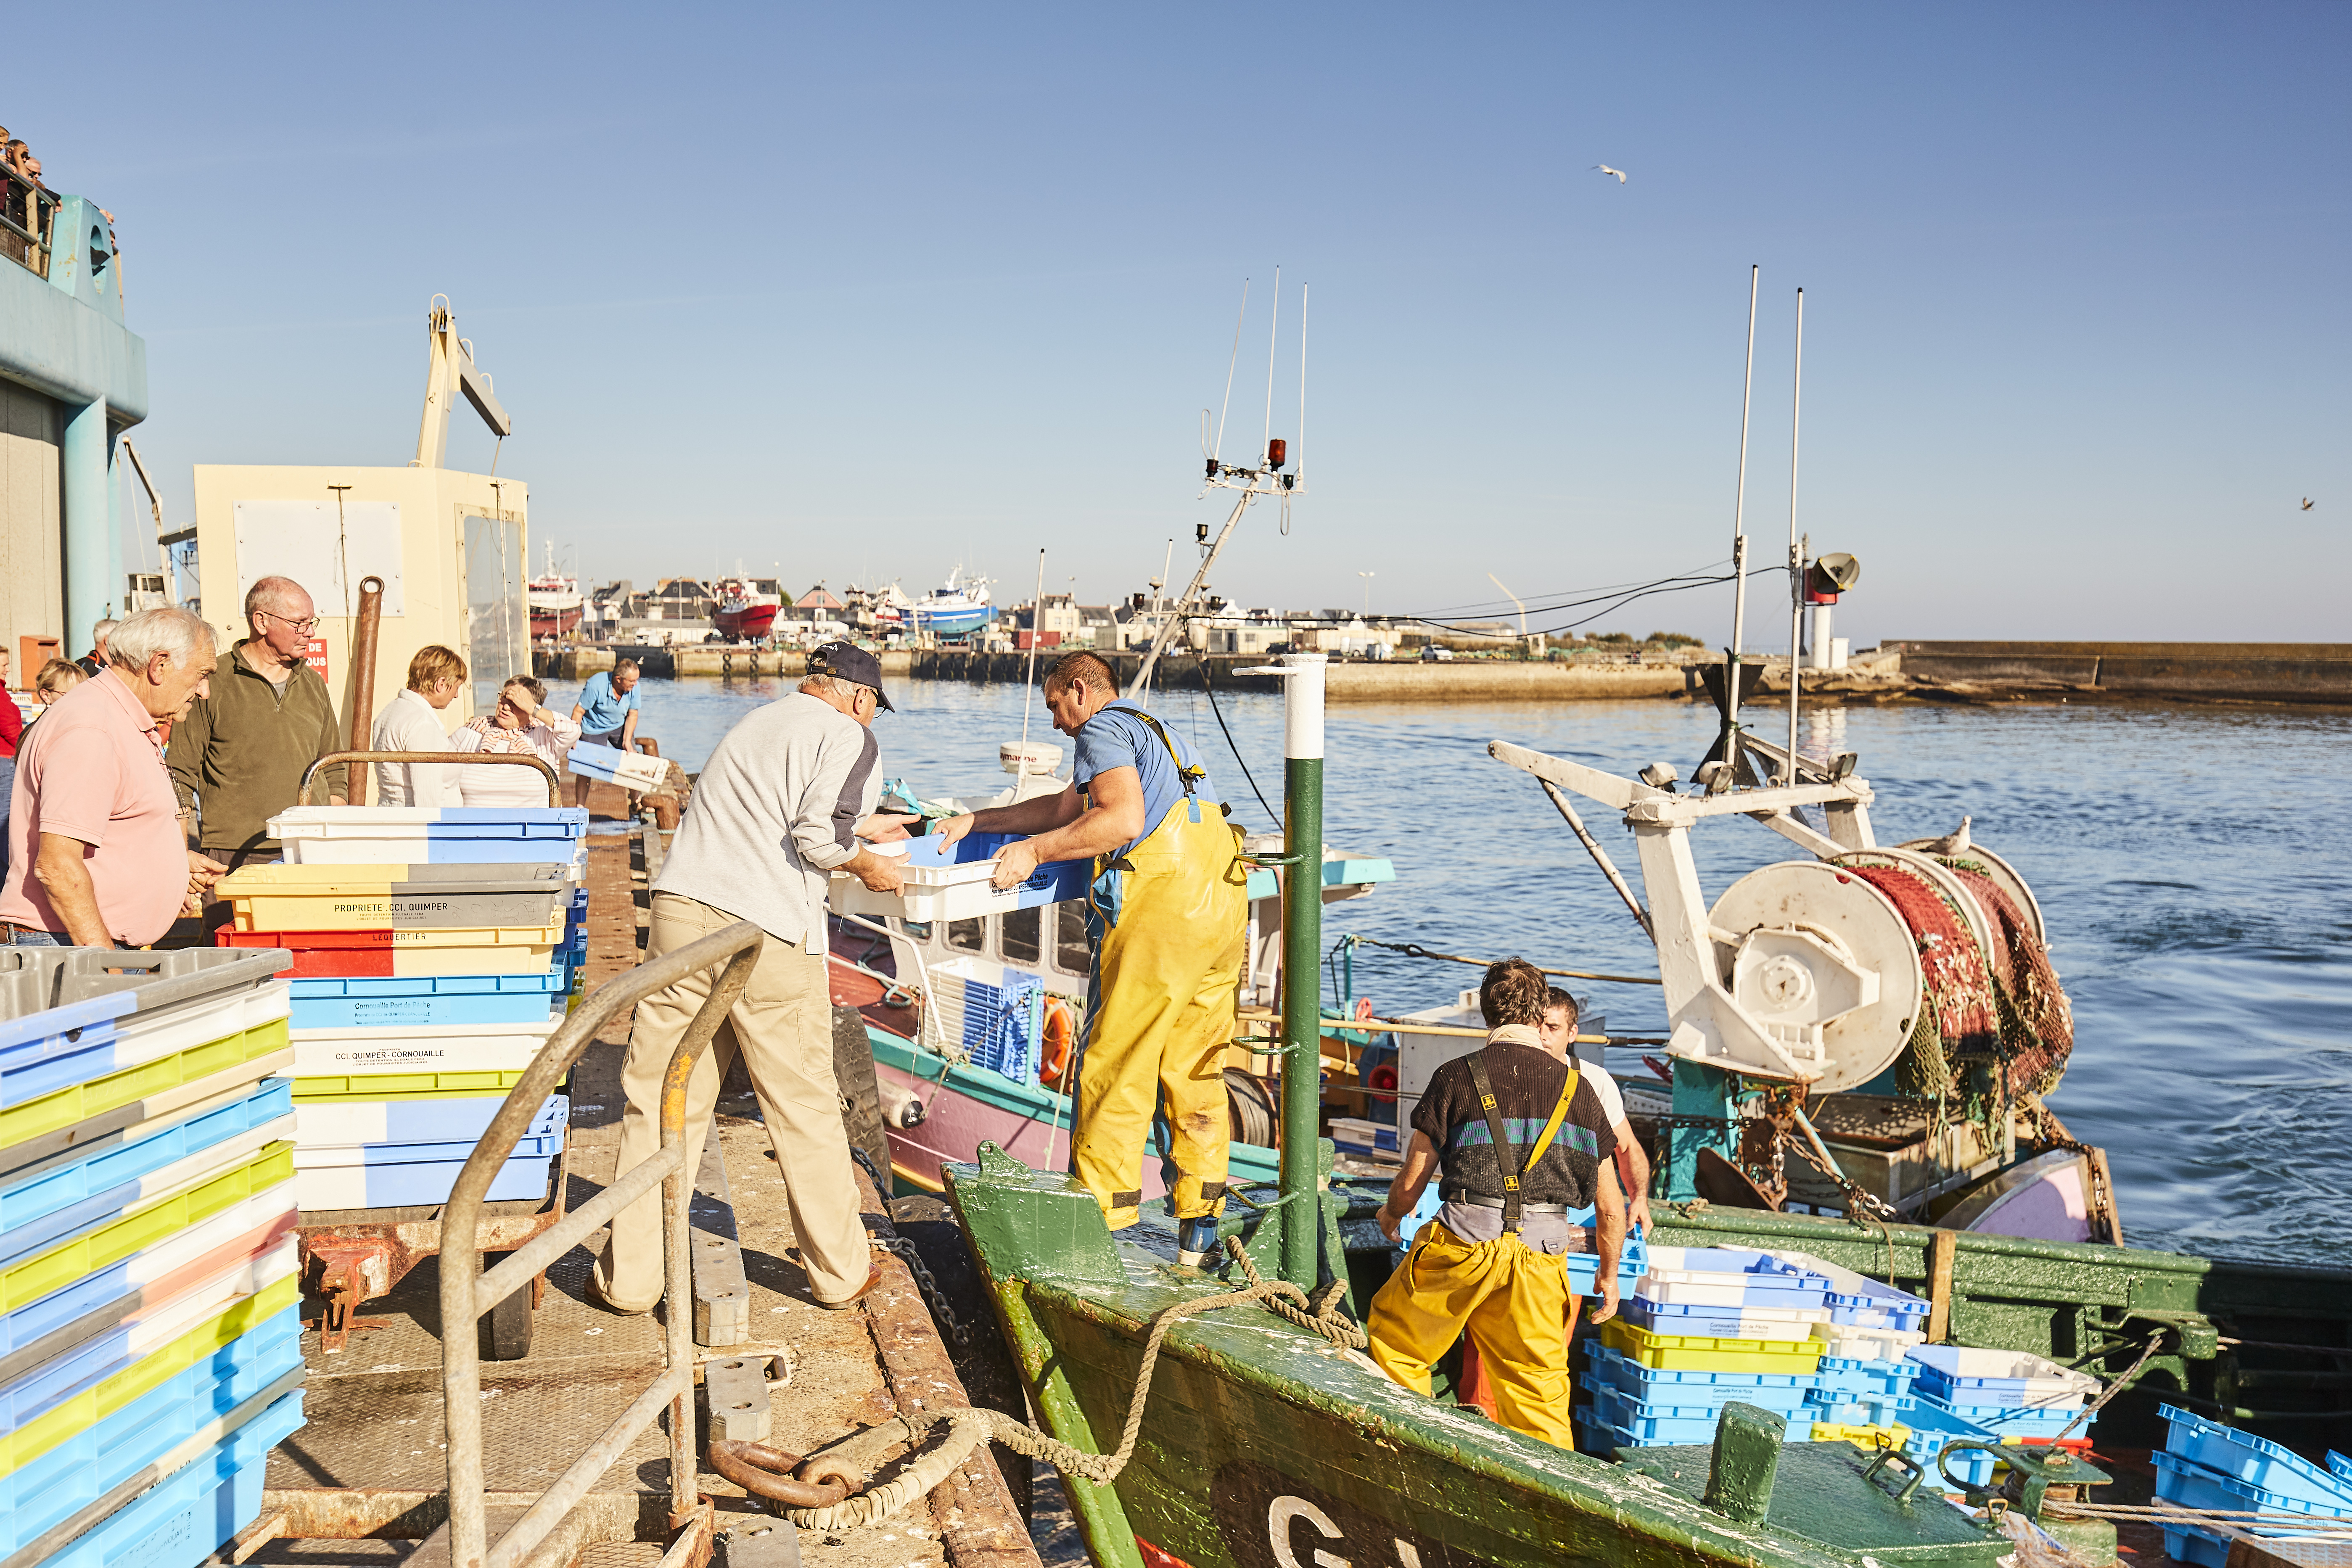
top-left (2147, 1406), bottom-right (2352, 1568)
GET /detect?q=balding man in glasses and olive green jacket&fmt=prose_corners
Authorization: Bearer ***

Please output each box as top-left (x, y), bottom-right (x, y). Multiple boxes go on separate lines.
top-left (167, 576), bottom-right (346, 870)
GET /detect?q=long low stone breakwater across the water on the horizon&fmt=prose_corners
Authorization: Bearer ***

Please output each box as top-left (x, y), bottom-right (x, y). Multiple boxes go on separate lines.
top-left (534, 639), bottom-right (2352, 707)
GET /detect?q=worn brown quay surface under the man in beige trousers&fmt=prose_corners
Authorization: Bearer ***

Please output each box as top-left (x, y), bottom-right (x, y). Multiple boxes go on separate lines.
top-left (236, 785), bottom-right (1037, 1568)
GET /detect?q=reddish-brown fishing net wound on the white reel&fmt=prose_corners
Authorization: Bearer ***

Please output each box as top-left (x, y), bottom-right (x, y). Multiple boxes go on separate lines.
top-left (1846, 861), bottom-right (2075, 1131)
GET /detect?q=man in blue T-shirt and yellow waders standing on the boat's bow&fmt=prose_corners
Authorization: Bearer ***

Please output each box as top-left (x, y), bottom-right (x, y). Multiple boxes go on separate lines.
top-left (938, 654), bottom-right (1249, 1262)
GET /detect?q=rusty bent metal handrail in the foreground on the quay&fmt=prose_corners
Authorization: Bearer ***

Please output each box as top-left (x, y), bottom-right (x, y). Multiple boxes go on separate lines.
top-left (440, 921), bottom-right (764, 1568)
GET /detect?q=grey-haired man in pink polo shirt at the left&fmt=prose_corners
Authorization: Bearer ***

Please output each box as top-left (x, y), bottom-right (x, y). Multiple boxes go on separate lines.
top-left (0, 609), bottom-right (228, 948)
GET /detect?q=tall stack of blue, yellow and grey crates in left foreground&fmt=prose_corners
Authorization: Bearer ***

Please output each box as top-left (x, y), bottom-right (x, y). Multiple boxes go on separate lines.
top-left (0, 948), bottom-right (304, 1568)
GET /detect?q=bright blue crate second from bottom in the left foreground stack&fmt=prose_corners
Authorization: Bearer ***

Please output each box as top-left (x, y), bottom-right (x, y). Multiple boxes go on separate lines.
top-left (0, 1305), bottom-right (304, 1552)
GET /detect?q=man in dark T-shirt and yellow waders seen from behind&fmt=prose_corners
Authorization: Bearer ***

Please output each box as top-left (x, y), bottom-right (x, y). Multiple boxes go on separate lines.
top-left (1364, 959), bottom-right (1625, 1448)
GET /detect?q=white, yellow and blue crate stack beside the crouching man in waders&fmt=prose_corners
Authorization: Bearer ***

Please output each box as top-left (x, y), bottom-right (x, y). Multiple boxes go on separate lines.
top-left (1578, 1246), bottom-right (1830, 1453)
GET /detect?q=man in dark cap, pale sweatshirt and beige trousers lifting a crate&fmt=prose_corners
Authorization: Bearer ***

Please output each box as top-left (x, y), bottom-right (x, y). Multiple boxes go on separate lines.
top-left (593, 642), bottom-right (910, 1312)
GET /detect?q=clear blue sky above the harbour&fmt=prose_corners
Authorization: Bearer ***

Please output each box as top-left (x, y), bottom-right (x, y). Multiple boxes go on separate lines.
top-left (37, 5), bottom-right (2352, 647)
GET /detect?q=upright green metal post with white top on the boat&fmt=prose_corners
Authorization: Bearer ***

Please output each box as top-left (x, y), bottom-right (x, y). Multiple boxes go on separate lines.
top-left (1277, 654), bottom-right (1324, 1291)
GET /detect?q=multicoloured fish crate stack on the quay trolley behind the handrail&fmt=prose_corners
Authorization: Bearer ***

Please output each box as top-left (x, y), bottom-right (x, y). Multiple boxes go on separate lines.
top-left (219, 806), bottom-right (588, 1213)
